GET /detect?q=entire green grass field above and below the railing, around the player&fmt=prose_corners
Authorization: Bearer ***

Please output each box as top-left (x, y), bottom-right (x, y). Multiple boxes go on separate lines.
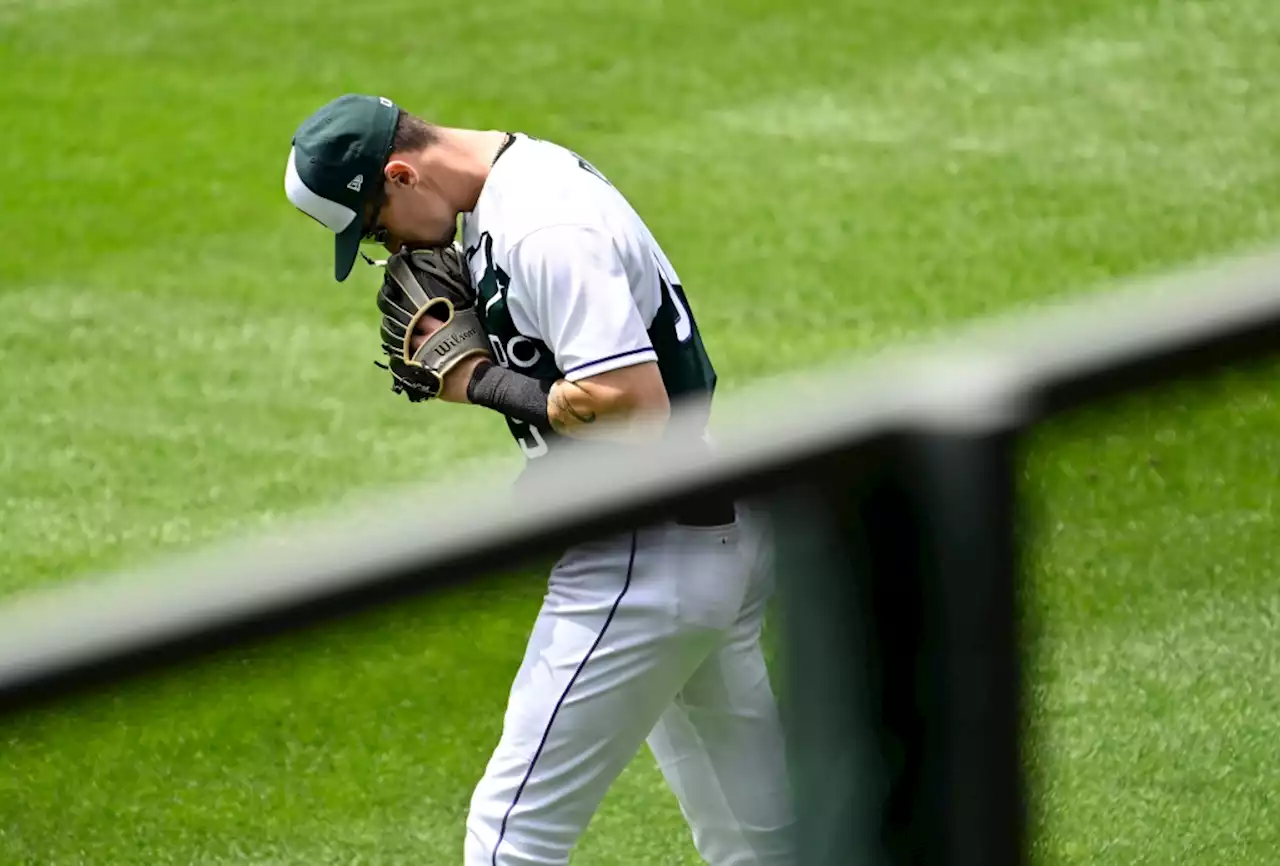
top-left (0, 0), bottom-right (1280, 866)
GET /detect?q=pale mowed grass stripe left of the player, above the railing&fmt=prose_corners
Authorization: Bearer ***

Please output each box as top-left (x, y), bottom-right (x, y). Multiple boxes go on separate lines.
top-left (0, 287), bottom-right (513, 591)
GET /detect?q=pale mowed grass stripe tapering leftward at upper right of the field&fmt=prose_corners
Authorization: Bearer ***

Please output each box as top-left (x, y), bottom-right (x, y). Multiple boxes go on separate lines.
top-left (714, 3), bottom-right (1280, 202)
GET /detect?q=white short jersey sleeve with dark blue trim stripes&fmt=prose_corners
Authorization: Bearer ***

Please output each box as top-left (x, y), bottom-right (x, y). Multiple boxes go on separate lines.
top-left (507, 225), bottom-right (658, 381)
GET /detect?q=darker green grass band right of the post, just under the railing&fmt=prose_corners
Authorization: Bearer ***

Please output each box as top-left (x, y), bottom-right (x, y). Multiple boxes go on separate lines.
top-left (1023, 363), bottom-right (1280, 624)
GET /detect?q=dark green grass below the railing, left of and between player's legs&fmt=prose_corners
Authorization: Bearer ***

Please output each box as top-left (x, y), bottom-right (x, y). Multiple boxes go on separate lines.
top-left (0, 570), bottom-right (698, 866)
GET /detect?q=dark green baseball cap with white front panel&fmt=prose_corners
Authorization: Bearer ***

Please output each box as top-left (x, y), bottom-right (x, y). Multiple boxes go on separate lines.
top-left (284, 93), bottom-right (399, 283)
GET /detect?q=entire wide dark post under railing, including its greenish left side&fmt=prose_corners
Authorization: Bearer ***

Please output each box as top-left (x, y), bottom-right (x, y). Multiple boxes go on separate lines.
top-left (772, 419), bottom-right (1025, 866)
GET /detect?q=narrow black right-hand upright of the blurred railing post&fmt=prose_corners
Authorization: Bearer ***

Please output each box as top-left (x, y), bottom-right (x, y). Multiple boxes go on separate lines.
top-left (905, 430), bottom-right (1027, 866)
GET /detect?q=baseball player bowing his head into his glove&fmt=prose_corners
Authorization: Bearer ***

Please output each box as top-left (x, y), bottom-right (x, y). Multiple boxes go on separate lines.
top-left (285, 95), bottom-right (795, 866)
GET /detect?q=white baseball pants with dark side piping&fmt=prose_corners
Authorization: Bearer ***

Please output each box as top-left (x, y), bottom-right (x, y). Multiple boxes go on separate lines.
top-left (465, 508), bottom-right (795, 866)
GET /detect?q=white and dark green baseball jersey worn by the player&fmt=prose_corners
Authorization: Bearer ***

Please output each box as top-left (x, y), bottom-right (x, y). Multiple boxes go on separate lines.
top-left (462, 136), bottom-right (716, 458)
